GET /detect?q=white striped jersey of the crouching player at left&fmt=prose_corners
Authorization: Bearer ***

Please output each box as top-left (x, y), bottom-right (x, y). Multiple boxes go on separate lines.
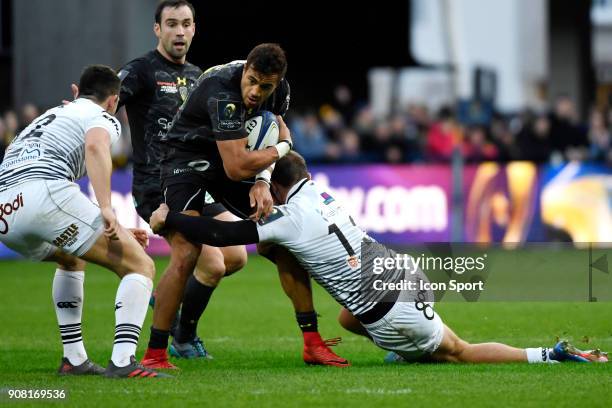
top-left (0, 98), bottom-right (121, 191)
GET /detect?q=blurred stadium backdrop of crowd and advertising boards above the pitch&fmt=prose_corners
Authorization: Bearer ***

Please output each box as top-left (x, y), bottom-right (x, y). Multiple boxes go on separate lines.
top-left (0, 0), bottom-right (612, 256)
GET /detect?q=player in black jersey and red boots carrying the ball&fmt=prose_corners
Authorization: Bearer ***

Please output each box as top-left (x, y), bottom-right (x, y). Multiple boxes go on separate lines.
top-left (142, 44), bottom-right (348, 368)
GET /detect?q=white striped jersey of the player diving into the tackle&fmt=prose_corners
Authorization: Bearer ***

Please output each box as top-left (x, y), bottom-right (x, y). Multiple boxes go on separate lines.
top-left (257, 179), bottom-right (395, 315)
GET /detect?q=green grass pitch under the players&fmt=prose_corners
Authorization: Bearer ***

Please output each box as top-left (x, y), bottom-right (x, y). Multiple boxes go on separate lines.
top-left (0, 257), bottom-right (612, 407)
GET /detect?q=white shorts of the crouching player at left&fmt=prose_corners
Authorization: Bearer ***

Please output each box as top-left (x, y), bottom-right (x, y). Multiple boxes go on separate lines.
top-left (0, 180), bottom-right (104, 261)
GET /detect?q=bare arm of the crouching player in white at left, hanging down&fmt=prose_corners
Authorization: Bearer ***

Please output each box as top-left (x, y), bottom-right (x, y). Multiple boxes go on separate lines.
top-left (85, 127), bottom-right (119, 239)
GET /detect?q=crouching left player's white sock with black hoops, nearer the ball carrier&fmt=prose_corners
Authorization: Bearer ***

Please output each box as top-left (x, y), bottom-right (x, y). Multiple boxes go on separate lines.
top-left (111, 273), bottom-right (153, 367)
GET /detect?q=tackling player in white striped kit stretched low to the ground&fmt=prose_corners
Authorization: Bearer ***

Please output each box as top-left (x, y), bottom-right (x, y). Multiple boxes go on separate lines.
top-left (151, 152), bottom-right (607, 363)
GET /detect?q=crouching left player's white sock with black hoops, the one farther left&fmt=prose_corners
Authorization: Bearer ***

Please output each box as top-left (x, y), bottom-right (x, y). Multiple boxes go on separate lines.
top-left (53, 268), bottom-right (87, 366)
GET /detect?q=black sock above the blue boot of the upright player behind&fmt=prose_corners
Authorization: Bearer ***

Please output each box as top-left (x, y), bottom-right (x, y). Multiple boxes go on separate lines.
top-left (174, 275), bottom-right (215, 343)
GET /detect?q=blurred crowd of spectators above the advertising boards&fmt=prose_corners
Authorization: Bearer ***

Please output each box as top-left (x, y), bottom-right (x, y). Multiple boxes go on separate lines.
top-left (0, 92), bottom-right (612, 167)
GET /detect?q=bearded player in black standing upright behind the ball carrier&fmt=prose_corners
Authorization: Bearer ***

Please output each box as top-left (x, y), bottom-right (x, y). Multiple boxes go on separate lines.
top-left (119, 0), bottom-right (246, 364)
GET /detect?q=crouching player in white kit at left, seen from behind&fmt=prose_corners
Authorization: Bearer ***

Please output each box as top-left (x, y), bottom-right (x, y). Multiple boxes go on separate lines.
top-left (0, 65), bottom-right (166, 377)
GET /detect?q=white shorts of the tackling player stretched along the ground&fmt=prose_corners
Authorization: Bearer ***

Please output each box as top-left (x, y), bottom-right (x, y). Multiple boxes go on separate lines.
top-left (363, 301), bottom-right (444, 361)
